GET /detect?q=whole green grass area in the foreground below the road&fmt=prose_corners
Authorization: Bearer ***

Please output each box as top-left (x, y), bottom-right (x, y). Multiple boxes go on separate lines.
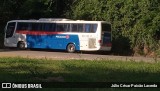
top-left (0, 57), bottom-right (160, 91)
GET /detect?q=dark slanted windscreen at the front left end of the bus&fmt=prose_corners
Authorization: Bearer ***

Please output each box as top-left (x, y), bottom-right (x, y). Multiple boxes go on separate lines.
top-left (6, 22), bottom-right (16, 38)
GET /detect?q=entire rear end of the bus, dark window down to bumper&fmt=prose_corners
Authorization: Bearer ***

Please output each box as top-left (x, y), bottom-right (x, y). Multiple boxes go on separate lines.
top-left (99, 23), bottom-right (112, 51)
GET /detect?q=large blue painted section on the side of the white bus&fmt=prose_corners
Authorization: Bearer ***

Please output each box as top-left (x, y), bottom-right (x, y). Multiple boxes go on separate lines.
top-left (26, 34), bottom-right (80, 50)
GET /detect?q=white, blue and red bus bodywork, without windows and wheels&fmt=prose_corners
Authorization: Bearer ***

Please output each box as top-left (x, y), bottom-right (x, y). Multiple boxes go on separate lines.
top-left (4, 20), bottom-right (111, 51)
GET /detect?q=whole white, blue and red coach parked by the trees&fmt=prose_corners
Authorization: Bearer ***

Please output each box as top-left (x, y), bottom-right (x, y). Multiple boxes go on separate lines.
top-left (4, 18), bottom-right (112, 53)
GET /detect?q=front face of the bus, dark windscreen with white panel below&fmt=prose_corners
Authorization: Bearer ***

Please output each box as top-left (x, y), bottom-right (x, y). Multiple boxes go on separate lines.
top-left (5, 22), bottom-right (17, 46)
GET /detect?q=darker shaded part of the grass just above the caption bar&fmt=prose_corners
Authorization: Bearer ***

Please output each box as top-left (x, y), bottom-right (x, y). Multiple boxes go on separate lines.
top-left (0, 61), bottom-right (160, 82)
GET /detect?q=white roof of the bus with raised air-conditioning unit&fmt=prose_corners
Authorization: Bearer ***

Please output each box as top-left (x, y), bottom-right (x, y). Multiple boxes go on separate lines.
top-left (9, 18), bottom-right (109, 23)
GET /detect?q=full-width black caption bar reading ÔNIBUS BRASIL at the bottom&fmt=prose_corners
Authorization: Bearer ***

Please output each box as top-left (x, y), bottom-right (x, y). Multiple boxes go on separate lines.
top-left (0, 82), bottom-right (160, 88)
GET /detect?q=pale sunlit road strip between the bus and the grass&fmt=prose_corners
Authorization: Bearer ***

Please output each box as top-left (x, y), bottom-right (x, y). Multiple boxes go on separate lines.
top-left (0, 49), bottom-right (160, 62)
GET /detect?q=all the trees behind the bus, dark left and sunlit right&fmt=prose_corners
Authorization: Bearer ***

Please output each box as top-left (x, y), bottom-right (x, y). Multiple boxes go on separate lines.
top-left (0, 0), bottom-right (160, 55)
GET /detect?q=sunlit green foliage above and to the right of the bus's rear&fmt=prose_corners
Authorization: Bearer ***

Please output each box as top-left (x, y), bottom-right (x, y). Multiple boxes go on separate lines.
top-left (69, 0), bottom-right (160, 54)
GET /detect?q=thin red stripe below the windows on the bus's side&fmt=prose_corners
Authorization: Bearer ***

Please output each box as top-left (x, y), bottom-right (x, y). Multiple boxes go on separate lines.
top-left (16, 30), bottom-right (63, 35)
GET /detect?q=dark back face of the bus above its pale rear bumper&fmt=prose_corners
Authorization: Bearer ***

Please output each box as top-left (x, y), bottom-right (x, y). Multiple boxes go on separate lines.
top-left (102, 23), bottom-right (112, 47)
